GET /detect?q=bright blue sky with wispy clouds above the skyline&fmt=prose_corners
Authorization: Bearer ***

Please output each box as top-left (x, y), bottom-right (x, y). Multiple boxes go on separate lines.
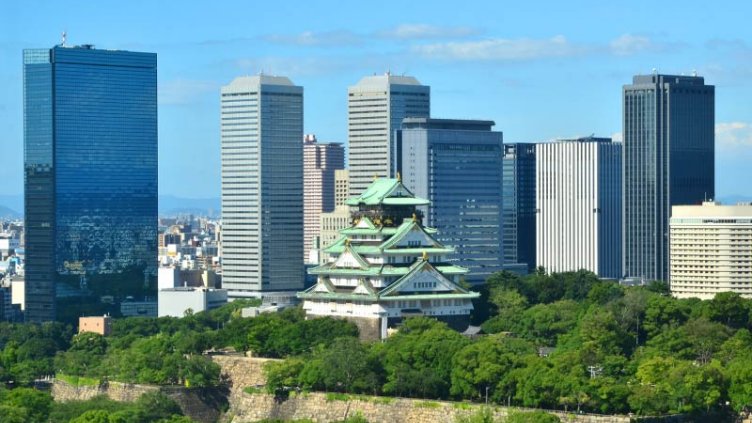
top-left (0, 0), bottom-right (752, 198)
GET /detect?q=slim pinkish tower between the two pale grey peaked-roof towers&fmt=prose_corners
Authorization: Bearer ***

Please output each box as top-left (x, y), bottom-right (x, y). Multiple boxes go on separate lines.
top-left (303, 135), bottom-right (345, 259)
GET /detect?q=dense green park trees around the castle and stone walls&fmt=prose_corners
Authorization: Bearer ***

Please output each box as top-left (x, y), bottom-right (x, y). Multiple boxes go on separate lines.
top-left (0, 271), bottom-right (752, 422)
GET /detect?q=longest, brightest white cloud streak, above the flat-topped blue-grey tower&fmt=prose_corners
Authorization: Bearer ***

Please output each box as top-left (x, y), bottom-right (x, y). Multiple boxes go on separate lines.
top-left (413, 35), bottom-right (588, 61)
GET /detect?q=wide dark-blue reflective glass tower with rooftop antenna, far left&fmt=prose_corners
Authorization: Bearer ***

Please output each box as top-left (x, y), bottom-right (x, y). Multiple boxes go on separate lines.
top-left (23, 45), bottom-right (157, 321)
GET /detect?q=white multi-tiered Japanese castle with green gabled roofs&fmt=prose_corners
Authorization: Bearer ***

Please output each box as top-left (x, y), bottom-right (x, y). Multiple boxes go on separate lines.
top-left (298, 178), bottom-right (480, 339)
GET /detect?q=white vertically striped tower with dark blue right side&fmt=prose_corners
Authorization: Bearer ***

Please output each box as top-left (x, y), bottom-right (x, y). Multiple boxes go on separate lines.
top-left (535, 137), bottom-right (622, 278)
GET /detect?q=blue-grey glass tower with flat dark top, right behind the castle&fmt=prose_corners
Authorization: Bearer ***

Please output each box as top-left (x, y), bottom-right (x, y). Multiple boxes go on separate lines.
top-left (396, 118), bottom-right (504, 283)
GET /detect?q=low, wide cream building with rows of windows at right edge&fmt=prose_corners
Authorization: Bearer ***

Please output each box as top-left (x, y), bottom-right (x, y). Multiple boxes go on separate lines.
top-left (670, 201), bottom-right (752, 300)
